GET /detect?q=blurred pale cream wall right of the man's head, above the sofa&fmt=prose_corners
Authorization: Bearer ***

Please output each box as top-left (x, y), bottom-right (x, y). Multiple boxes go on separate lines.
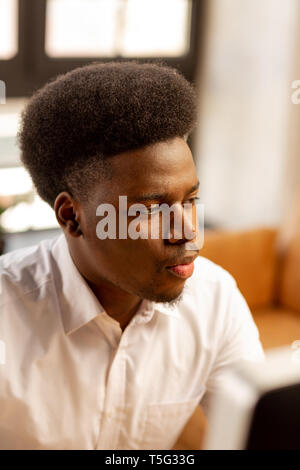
top-left (196, 0), bottom-right (300, 228)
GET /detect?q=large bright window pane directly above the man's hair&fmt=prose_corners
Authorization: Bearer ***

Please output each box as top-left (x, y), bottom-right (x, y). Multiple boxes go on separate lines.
top-left (45, 0), bottom-right (192, 57)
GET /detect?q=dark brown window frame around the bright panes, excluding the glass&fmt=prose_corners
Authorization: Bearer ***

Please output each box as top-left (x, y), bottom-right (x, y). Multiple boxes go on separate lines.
top-left (0, 0), bottom-right (205, 97)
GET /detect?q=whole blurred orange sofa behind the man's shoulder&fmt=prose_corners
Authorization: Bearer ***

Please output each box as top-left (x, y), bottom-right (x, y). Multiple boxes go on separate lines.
top-left (200, 228), bottom-right (300, 349)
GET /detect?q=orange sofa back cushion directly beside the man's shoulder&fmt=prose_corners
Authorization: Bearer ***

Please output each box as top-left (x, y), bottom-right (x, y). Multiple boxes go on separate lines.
top-left (200, 228), bottom-right (277, 308)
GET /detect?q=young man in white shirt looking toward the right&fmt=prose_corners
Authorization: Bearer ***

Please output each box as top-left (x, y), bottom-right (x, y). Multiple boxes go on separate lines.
top-left (0, 62), bottom-right (264, 449)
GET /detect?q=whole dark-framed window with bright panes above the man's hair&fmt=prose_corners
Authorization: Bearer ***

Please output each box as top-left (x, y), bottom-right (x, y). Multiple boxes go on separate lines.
top-left (0, 0), bottom-right (202, 96)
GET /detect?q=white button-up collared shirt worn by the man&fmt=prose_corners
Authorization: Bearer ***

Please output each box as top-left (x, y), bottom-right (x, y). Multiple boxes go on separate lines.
top-left (0, 234), bottom-right (265, 449)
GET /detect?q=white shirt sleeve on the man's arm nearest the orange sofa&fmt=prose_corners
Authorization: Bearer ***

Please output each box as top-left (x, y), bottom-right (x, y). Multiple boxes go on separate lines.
top-left (200, 283), bottom-right (266, 418)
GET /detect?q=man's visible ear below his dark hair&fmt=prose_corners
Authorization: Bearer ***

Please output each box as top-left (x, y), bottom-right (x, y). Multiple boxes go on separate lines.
top-left (53, 191), bottom-right (83, 238)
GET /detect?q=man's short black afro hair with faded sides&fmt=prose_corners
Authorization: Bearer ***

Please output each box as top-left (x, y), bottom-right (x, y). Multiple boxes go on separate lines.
top-left (18, 61), bottom-right (196, 207)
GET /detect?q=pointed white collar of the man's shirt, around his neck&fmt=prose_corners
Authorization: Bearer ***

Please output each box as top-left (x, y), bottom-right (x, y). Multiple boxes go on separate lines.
top-left (52, 233), bottom-right (179, 335)
